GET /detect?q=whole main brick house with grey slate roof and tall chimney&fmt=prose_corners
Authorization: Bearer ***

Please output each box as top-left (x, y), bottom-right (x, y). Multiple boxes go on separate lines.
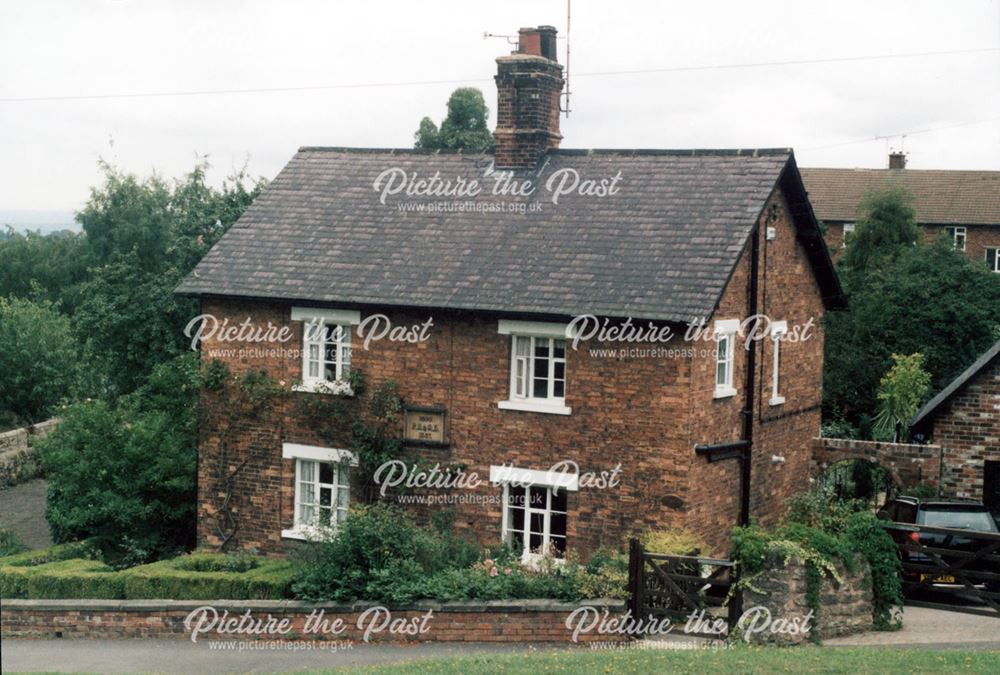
top-left (178, 27), bottom-right (843, 556)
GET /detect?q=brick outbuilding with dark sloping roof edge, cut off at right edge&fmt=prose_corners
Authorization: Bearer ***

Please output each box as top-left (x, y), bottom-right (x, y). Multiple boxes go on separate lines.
top-left (913, 342), bottom-right (1000, 514)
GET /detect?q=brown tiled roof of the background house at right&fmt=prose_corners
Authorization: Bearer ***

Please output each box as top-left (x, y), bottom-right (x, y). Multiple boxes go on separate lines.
top-left (799, 168), bottom-right (1000, 227)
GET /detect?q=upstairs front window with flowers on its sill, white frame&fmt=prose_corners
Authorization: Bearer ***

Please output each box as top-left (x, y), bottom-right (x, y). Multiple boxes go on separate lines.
top-left (292, 307), bottom-right (361, 394)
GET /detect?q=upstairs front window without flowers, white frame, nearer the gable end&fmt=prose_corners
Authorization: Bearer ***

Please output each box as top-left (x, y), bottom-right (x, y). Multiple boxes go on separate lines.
top-left (498, 321), bottom-right (571, 415)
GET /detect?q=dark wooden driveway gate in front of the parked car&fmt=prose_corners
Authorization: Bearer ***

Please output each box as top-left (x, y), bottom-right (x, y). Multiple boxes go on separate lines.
top-left (884, 523), bottom-right (1000, 616)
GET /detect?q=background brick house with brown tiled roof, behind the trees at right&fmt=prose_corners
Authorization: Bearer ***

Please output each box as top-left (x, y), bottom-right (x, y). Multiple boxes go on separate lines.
top-left (801, 153), bottom-right (1000, 273)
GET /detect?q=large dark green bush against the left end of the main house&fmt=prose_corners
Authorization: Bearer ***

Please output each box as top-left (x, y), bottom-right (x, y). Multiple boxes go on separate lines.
top-left (39, 354), bottom-right (200, 567)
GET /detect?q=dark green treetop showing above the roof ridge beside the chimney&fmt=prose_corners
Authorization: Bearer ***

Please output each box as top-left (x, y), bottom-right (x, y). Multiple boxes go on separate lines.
top-left (413, 87), bottom-right (493, 152)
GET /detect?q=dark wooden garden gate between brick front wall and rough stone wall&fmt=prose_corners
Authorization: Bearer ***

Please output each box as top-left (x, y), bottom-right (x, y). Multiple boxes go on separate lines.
top-left (629, 539), bottom-right (741, 637)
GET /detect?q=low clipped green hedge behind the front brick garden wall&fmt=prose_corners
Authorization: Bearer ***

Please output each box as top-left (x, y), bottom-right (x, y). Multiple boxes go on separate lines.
top-left (0, 544), bottom-right (292, 600)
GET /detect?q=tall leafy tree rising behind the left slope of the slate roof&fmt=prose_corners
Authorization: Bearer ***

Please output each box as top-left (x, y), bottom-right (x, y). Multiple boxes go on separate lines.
top-left (73, 162), bottom-right (263, 394)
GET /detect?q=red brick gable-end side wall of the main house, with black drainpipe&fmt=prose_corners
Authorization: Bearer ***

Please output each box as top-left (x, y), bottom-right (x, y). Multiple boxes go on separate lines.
top-left (689, 193), bottom-right (824, 550)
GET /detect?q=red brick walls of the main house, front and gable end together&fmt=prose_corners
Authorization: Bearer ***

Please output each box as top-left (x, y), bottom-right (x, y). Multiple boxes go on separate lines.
top-left (198, 182), bottom-right (823, 557)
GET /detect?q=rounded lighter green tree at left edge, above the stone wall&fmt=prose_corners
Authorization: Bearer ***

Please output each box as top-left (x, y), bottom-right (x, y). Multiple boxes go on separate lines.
top-left (0, 297), bottom-right (80, 426)
